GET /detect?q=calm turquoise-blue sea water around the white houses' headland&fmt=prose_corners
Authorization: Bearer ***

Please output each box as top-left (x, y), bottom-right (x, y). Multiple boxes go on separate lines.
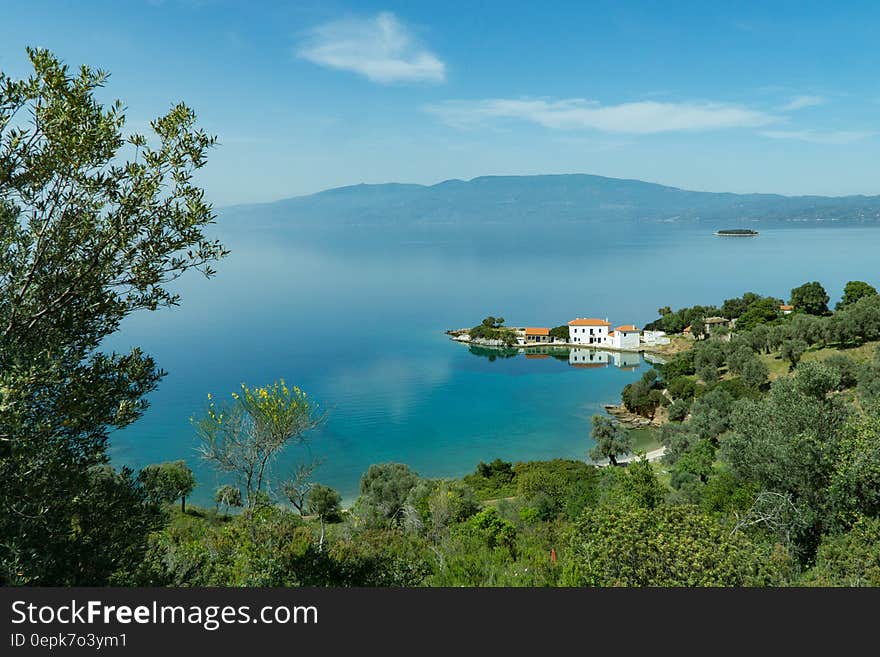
top-left (109, 218), bottom-right (880, 502)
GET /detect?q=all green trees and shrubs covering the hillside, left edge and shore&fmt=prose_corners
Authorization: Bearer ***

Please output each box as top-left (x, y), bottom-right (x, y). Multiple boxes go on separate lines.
top-left (0, 50), bottom-right (880, 586)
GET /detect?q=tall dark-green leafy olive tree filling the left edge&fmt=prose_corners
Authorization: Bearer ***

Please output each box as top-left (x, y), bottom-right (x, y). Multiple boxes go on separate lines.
top-left (0, 49), bottom-right (225, 585)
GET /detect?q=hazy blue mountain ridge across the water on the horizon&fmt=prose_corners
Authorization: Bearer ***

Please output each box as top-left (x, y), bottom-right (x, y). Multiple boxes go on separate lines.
top-left (220, 174), bottom-right (880, 226)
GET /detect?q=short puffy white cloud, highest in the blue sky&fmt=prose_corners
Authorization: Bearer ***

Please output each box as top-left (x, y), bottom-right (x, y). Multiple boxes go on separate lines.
top-left (298, 12), bottom-right (446, 84)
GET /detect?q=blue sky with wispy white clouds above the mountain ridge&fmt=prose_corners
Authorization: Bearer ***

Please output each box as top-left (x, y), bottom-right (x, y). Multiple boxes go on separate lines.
top-left (0, 0), bottom-right (880, 206)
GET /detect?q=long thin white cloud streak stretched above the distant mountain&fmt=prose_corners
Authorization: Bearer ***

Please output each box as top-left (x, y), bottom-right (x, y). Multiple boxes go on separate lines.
top-left (425, 98), bottom-right (777, 134)
